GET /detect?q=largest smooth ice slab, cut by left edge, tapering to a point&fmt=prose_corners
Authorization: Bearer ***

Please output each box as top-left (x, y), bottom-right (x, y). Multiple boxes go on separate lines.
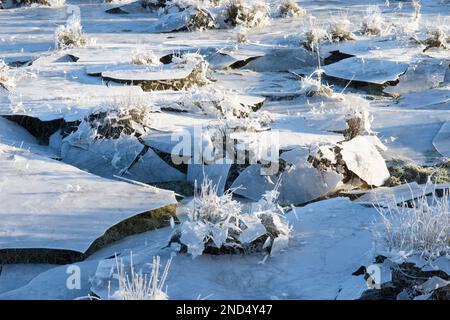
top-left (0, 145), bottom-right (176, 253)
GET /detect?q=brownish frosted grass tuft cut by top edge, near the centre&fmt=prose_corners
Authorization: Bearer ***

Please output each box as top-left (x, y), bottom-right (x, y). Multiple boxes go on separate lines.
top-left (224, 0), bottom-right (270, 28)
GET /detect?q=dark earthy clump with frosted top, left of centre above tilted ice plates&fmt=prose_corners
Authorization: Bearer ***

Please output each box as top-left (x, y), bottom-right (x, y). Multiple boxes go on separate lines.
top-left (72, 95), bottom-right (159, 139)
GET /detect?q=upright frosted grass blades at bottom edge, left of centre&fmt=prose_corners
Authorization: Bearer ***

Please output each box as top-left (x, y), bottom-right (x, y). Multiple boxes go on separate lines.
top-left (109, 256), bottom-right (171, 300)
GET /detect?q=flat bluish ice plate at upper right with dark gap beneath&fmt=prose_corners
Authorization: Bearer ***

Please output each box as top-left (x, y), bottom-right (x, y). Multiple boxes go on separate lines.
top-left (322, 57), bottom-right (408, 85)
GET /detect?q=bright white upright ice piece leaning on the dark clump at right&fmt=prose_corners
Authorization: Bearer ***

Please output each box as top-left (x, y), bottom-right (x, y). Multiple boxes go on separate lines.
top-left (341, 136), bottom-right (390, 186)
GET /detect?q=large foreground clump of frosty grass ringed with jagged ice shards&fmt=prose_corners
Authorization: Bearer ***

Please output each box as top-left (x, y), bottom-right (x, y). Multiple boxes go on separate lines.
top-left (172, 178), bottom-right (290, 258)
